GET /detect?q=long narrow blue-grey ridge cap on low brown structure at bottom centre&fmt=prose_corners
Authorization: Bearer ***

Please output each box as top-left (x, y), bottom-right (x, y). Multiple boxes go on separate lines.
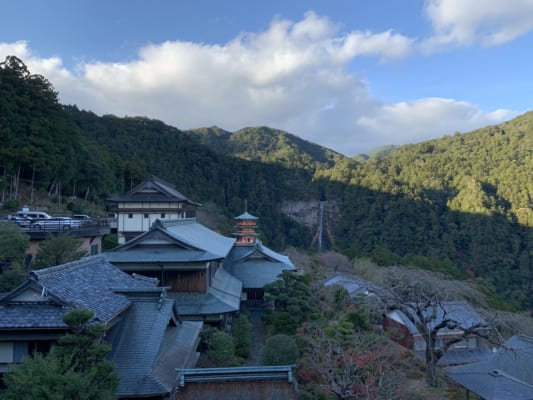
top-left (176, 365), bottom-right (295, 387)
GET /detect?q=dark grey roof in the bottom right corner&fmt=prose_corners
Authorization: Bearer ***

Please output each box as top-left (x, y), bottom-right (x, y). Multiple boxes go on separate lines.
top-left (445, 335), bottom-right (533, 400)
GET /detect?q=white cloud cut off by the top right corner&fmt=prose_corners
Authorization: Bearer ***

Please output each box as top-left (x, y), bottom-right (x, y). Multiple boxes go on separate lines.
top-left (424, 0), bottom-right (533, 50)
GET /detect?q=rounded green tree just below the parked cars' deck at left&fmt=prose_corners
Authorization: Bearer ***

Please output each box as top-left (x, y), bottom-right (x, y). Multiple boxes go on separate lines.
top-left (33, 234), bottom-right (87, 269)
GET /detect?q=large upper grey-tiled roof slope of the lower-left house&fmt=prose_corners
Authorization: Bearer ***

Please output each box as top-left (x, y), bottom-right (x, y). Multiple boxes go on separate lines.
top-left (31, 256), bottom-right (156, 323)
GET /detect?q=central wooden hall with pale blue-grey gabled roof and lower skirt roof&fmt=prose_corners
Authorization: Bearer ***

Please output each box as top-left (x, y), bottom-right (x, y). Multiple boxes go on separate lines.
top-left (106, 218), bottom-right (242, 325)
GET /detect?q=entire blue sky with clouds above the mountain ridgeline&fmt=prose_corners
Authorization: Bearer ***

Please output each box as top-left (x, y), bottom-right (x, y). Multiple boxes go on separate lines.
top-left (0, 0), bottom-right (533, 155)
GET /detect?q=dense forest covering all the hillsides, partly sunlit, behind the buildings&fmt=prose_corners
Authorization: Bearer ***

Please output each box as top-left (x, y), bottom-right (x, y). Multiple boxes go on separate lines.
top-left (0, 57), bottom-right (533, 309)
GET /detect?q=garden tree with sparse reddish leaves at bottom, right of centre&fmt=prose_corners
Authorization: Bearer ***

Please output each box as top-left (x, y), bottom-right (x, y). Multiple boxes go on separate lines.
top-left (298, 321), bottom-right (400, 400)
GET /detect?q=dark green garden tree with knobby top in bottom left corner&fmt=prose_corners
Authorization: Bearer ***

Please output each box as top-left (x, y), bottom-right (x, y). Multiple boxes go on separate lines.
top-left (0, 309), bottom-right (119, 400)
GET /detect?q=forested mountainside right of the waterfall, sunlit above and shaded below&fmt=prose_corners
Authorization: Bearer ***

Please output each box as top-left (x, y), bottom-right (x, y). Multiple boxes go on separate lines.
top-left (322, 113), bottom-right (533, 308)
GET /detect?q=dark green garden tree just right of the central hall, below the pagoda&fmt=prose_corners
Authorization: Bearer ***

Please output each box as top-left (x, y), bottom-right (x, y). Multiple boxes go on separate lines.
top-left (264, 271), bottom-right (317, 335)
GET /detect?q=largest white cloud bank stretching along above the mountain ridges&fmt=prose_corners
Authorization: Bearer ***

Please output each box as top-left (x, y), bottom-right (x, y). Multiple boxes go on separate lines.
top-left (0, 12), bottom-right (508, 155)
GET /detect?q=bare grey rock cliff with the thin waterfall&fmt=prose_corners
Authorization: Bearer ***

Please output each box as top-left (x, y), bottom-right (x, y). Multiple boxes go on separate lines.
top-left (281, 200), bottom-right (340, 249)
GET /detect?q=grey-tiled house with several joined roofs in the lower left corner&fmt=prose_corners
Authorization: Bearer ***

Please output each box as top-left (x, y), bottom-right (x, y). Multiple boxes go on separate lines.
top-left (0, 256), bottom-right (202, 400)
